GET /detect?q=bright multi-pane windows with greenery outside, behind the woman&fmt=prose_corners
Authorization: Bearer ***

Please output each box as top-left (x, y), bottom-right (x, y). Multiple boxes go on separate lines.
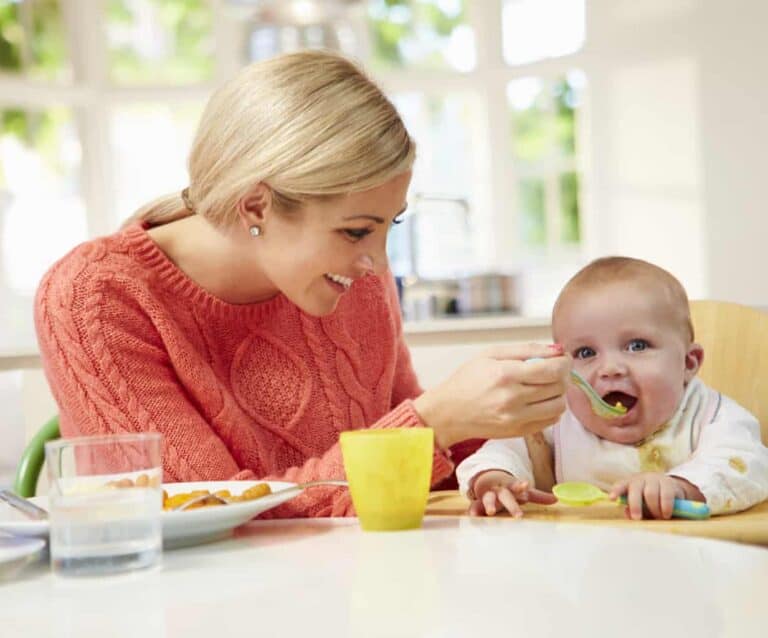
top-left (0, 0), bottom-right (586, 351)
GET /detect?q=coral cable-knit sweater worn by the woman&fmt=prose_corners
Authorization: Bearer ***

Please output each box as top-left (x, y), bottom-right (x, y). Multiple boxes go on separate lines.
top-left (35, 224), bottom-right (453, 516)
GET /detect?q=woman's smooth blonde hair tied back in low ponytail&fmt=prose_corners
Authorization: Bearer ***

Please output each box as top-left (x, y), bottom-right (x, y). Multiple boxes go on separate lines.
top-left (126, 51), bottom-right (416, 226)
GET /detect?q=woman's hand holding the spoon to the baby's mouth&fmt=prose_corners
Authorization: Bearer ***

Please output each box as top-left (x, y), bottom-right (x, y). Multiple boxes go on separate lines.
top-left (414, 343), bottom-right (572, 449)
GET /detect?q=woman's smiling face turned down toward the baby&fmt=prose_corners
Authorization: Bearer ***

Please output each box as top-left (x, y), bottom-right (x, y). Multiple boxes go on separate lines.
top-left (252, 171), bottom-right (411, 317)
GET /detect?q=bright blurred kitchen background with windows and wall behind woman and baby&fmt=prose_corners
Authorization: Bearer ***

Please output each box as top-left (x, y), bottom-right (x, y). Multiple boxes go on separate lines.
top-left (0, 0), bottom-right (768, 482)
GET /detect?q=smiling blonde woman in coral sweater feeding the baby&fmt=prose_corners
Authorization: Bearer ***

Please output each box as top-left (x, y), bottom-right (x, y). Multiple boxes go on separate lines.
top-left (36, 52), bottom-right (570, 516)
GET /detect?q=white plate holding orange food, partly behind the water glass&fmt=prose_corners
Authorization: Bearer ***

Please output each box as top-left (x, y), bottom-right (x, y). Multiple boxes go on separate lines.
top-left (0, 481), bottom-right (303, 548)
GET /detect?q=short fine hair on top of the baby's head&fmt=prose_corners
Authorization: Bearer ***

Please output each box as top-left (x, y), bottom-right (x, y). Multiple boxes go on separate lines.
top-left (552, 257), bottom-right (694, 342)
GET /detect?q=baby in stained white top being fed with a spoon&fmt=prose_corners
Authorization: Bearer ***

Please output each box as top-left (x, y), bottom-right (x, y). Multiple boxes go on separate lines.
top-left (456, 257), bottom-right (768, 519)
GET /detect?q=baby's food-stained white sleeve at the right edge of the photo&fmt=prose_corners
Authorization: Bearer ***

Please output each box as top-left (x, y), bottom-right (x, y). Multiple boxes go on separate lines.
top-left (667, 396), bottom-right (768, 514)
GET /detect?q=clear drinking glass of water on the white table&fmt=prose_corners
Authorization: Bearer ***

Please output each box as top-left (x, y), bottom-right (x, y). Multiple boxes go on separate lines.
top-left (45, 432), bottom-right (162, 576)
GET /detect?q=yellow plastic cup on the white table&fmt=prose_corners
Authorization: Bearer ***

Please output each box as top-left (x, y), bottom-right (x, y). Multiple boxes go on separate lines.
top-left (340, 428), bottom-right (434, 531)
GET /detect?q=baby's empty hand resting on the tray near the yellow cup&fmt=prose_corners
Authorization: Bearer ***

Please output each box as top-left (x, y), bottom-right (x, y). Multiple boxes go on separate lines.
top-left (469, 470), bottom-right (557, 518)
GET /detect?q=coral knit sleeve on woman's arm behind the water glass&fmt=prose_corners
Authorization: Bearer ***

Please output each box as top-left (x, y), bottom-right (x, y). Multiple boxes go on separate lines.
top-left (35, 268), bottom-right (254, 482)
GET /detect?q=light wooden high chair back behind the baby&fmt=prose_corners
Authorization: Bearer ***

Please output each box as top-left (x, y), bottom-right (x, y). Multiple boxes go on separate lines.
top-left (691, 300), bottom-right (768, 445)
